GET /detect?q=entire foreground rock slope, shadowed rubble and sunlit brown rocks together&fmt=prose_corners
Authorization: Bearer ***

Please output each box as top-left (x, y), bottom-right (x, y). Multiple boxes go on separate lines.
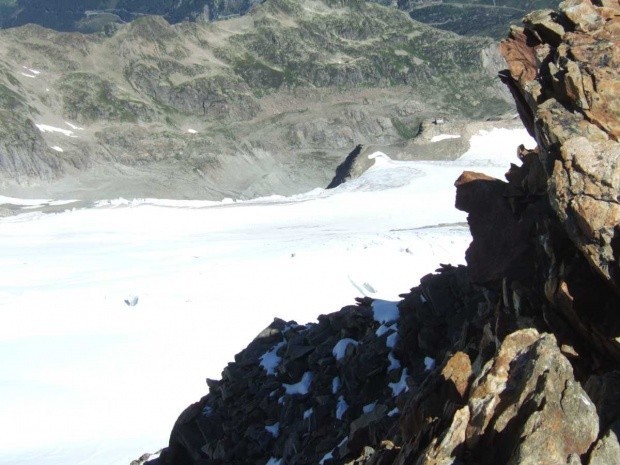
top-left (144, 0), bottom-right (620, 465)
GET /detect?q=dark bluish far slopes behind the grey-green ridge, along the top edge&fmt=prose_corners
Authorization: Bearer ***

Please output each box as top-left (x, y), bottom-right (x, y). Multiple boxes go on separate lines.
top-left (0, 0), bottom-right (559, 38)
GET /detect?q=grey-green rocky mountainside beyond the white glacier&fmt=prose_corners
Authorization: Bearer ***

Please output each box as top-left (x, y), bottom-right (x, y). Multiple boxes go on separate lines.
top-left (0, 0), bottom-right (514, 199)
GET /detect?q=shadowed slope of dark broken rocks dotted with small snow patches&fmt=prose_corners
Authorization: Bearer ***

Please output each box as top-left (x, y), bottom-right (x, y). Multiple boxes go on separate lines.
top-left (144, 266), bottom-right (485, 465)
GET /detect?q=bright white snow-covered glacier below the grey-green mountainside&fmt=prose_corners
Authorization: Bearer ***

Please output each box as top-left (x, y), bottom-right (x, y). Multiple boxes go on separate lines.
top-left (0, 129), bottom-right (533, 465)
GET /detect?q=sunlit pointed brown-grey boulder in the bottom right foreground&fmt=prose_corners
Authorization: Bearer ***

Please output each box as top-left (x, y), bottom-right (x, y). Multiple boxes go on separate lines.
top-left (466, 329), bottom-right (598, 464)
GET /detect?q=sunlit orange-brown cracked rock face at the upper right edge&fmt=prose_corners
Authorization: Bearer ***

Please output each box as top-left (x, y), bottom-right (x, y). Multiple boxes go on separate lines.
top-left (501, 0), bottom-right (620, 292)
